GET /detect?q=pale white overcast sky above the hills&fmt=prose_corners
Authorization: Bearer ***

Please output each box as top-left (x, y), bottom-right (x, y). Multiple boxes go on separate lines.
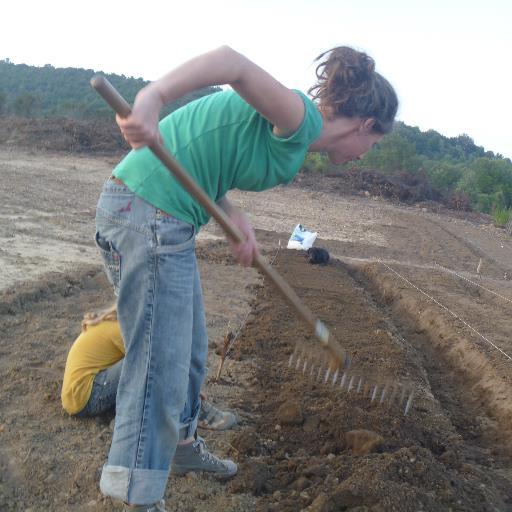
top-left (0, 0), bottom-right (512, 158)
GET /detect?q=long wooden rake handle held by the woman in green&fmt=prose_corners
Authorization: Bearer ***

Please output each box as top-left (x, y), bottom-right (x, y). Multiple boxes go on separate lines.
top-left (91, 75), bottom-right (345, 365)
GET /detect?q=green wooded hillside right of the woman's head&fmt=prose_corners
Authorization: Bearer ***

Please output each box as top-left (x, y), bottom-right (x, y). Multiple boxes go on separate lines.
top-left (305, 122), bottom-right (512, 226)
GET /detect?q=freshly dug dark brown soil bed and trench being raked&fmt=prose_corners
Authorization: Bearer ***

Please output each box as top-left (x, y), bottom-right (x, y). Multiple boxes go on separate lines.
top-left (231, 251), bottom-right (512, 512)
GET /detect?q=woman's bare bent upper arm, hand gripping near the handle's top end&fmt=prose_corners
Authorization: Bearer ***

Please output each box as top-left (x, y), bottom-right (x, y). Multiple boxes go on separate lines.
top-left (118, 46), bottom-right (304, 148)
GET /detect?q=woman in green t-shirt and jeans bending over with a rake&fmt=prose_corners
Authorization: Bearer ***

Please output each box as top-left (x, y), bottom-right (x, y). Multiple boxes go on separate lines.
top-left (96, 46), bottom-right (398, 511)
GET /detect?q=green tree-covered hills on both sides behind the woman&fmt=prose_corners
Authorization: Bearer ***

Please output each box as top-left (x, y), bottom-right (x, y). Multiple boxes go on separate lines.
top-left (0, 59), bottom-right (512, 224)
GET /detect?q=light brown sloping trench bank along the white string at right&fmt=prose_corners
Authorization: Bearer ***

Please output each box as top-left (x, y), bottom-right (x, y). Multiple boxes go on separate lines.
top-left (352, 264), bottom-right (512, 455)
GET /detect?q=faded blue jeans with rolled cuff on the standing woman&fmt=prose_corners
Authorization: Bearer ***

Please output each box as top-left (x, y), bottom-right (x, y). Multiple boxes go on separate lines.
top-left (95, 180), bottom-right (208, 504)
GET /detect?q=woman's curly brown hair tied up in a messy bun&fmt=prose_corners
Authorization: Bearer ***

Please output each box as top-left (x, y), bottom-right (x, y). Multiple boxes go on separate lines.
top-left (308, 46), bottom-right (398, 135)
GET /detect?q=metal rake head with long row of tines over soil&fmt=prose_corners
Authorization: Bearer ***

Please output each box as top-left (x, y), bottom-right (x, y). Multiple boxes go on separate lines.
top-left (288, 347), bottom-right (415, 415)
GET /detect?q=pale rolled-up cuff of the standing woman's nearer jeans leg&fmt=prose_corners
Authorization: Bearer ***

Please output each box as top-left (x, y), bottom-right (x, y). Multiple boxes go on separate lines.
top-left (100, 464), bottom-right (169, 505)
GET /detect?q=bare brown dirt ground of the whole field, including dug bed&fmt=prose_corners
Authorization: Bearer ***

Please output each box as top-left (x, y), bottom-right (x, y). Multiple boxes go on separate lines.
top-left (0, 146), bottom-right (512, 512)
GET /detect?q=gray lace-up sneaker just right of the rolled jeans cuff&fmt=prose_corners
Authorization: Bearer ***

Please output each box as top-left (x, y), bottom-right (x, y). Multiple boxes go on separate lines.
top-left (171, 436), bottom-right (238, 479)
